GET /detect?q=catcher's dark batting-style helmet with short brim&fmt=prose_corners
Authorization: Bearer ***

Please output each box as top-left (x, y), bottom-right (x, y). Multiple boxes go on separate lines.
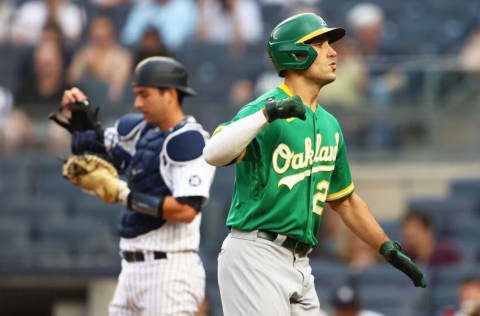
top-left (132, 56), bottom-right (197, 95)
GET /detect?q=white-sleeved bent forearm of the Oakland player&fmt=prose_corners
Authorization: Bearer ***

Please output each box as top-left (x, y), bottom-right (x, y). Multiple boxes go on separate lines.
top-left (203, 110), bottom-right (268, 166)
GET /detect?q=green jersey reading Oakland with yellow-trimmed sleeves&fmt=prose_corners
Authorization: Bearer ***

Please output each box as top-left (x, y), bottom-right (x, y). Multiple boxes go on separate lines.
top-left (215, 84), bottom-right (354, 246)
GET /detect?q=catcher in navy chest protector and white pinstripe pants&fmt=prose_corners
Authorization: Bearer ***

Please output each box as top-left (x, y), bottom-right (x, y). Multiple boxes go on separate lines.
top-left (51, 57), bottom-right (215, 315)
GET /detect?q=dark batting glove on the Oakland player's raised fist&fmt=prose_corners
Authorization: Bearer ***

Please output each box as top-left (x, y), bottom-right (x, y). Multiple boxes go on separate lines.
top-left (265, 95), bottom-right (306, 122)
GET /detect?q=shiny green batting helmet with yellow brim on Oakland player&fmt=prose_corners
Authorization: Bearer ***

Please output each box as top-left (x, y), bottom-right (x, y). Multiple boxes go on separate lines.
top-left (267, 13), bottom-right (345, 77)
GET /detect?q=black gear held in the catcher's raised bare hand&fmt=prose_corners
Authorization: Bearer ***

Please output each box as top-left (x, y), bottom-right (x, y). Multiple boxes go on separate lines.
top-left (48, 100), bottom-right (103, 135)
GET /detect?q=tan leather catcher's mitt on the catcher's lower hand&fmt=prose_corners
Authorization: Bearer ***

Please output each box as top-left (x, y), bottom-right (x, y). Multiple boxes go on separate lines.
top-left (62, 155), bottom-right (130, 203)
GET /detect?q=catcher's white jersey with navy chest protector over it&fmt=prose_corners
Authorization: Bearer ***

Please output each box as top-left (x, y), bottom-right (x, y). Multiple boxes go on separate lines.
top-left (105, 114), bottom-right (215, 252)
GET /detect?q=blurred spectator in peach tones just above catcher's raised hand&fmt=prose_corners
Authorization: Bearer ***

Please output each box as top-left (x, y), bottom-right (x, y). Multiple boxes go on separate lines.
top-left (68, 15), bottom-right (132, 104)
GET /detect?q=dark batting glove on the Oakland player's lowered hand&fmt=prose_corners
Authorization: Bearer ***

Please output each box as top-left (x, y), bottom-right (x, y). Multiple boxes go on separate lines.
top-left (379, 240), bottom-right (427, 287)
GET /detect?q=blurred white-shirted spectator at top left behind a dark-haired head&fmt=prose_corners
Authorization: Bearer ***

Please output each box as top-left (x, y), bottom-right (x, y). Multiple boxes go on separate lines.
top-left (11, 0), bottom-right (86, 45)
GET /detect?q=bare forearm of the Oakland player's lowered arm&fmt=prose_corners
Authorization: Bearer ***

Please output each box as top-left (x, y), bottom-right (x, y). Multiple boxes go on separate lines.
top-left (330, 193), bottom-right (389, 250)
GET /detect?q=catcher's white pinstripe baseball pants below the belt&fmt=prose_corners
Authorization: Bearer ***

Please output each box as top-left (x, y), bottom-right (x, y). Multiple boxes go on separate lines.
top-left (109, 252), bottom-right (205, 316)
